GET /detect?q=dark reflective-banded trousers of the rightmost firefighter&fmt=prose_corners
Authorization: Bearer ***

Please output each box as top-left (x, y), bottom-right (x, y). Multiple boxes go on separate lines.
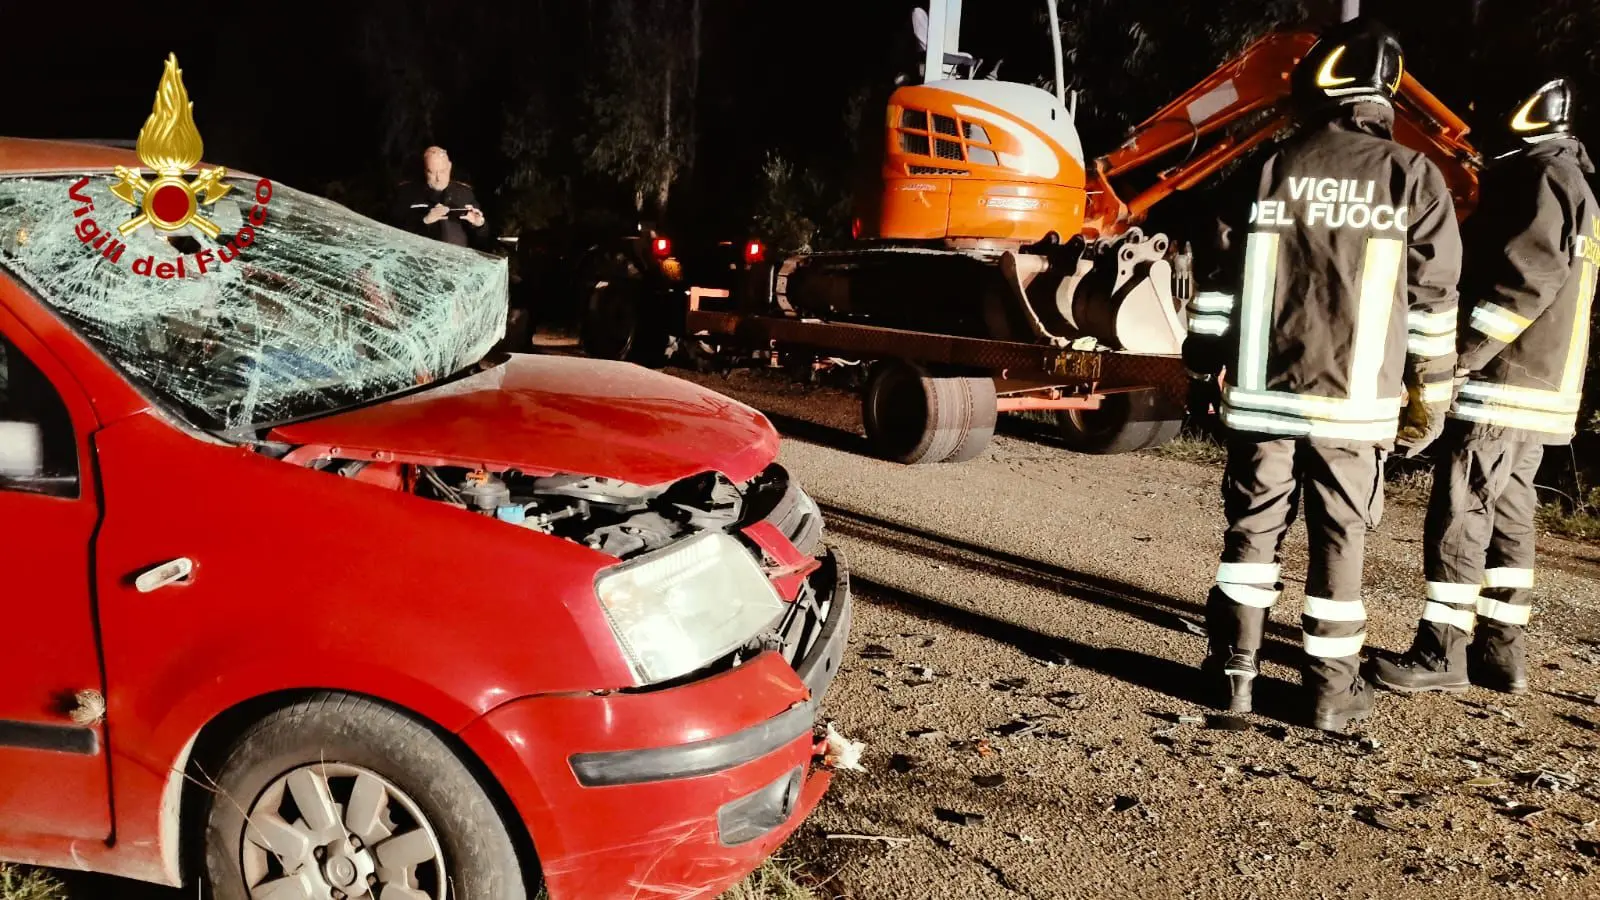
top-left (1418, 428), bottom-right (1544, 650)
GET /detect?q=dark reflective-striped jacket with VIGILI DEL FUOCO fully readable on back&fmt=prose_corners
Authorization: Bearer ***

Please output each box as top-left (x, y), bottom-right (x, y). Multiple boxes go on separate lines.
top-left (1184, 101), bottom-right (1461, 445)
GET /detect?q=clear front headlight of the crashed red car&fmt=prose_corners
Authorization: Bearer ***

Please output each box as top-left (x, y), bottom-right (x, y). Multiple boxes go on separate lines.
top-left (595, 532), bottom-right (784, 684)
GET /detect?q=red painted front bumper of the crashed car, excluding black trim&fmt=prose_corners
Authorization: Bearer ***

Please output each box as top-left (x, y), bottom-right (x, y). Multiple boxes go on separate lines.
top-left (461, 653), bottom-right (827, 900)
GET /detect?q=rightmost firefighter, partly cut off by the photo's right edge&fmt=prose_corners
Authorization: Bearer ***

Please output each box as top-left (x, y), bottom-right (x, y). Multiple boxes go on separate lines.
top-left (1373, 78), bottom-right (1600, 693)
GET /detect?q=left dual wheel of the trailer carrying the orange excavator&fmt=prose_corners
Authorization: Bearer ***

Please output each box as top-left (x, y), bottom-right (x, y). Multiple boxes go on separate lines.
top-left (861, 360), bottom-right (997, 466)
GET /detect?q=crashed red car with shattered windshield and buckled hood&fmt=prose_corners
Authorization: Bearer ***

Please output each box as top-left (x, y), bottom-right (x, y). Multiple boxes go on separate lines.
top-left (0, 139), bottom-right (851, 900)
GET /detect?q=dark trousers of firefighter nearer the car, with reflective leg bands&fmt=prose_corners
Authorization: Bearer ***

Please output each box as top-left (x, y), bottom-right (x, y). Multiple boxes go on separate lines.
top-left (1206, 436), bottom-right (1384, 692)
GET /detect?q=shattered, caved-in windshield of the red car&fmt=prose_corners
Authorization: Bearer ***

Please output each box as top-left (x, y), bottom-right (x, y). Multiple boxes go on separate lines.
top-left (0, 173), bottom-right (506, 432)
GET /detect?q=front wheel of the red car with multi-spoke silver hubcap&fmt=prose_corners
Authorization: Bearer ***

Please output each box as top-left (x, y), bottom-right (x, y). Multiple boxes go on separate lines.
top-left (205, 693), bottom-right (539, 900)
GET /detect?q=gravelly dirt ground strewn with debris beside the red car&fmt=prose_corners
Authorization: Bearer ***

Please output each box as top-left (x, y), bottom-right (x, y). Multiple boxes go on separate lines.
top-left (678, 366), bottom-right (1600, 900)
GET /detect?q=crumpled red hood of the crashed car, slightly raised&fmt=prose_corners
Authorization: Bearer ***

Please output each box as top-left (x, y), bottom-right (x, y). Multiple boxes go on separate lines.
top-left (270, 356), bottom-right (778, 485)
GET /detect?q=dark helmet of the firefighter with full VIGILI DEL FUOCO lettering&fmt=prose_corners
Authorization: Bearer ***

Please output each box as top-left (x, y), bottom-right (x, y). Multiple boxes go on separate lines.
top-left (1293, 19), bottom-right (1405, 106)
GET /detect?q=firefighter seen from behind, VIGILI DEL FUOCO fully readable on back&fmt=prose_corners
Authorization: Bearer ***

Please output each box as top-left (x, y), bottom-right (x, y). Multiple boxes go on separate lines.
top-left (1184, 19), bottom-right (1461, 730)
